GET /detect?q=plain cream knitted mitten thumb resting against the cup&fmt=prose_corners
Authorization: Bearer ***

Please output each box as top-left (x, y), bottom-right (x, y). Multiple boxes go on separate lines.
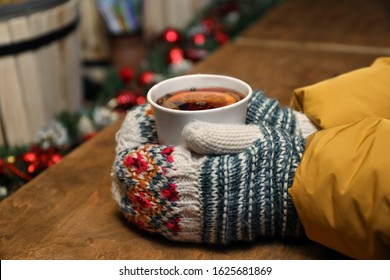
top-left (182, 121), bottom-right (261, 155)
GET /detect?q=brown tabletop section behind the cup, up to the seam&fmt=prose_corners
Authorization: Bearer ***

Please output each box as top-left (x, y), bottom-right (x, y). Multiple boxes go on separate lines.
top-left (191, 43), bottom-right (377, 105)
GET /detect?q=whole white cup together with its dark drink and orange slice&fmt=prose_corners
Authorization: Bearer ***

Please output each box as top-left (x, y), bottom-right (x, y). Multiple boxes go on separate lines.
top-left (147, 74), bottom-right (252, 145)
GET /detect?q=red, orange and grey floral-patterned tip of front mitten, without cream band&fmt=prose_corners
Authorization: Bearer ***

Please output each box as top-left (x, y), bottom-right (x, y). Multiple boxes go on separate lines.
top-left (113, 145), bottom-right (180, 238)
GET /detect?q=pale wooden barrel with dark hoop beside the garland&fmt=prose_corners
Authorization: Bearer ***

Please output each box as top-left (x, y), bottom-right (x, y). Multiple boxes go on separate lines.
top-left (0, 0), bottom-right (82, 146)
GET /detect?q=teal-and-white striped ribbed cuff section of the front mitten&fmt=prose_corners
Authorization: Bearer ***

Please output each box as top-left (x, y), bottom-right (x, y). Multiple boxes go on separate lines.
top-left (200, 122), bottom-right (305, 243)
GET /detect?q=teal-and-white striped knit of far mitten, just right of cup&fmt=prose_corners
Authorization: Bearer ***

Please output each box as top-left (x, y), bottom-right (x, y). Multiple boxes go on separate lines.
top-left (246, 90), bottom-right (299, 135)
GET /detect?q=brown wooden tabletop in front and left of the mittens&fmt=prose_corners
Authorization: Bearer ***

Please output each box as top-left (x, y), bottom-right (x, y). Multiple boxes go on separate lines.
top-left (0, 116), bottom-right (345, 260)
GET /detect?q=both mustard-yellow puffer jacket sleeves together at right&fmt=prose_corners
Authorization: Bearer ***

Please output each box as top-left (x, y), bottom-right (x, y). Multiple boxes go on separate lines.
top-left (289, 57), bottom-right (390, 259)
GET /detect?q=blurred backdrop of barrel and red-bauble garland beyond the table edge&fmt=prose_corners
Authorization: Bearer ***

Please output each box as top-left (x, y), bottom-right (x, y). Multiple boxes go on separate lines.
top-left (0, 0), bottom-right (282, 199)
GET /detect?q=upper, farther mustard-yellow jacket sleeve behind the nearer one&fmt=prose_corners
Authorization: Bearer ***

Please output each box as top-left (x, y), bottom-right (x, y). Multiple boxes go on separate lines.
top-left (290, 57), bottom-right (390, 129)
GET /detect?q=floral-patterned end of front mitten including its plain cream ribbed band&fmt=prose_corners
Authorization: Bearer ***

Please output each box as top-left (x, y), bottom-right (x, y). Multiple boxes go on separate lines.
top-left (111, 145), bottom-right (202, 242)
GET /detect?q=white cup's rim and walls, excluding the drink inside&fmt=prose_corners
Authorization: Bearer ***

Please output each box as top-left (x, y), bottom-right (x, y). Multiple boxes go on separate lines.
top-left (147, 74), bottom-right (252, 145)
